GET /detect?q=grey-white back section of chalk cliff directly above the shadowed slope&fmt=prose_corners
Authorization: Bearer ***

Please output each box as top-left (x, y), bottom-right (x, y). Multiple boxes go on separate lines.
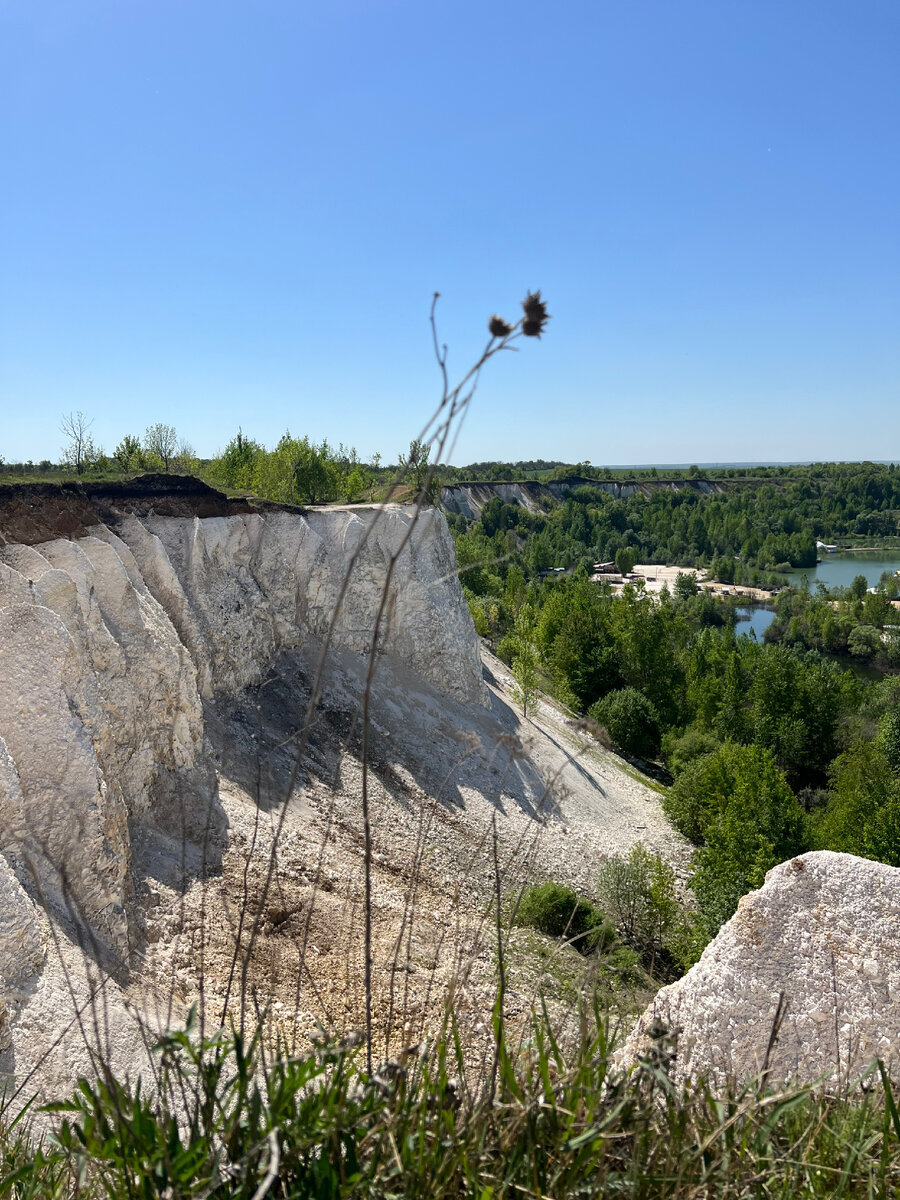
top-left (110, 505), bottom-right (486, 703)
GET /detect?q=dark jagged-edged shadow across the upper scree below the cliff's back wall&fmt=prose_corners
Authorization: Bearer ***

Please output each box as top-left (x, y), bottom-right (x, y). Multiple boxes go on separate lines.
top-left (205, 648), bottom-right (558, 820)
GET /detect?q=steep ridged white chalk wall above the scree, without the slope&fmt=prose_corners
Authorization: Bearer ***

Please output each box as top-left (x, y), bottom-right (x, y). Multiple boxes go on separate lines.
top-left (0, 489), bottom-right (485, 1003)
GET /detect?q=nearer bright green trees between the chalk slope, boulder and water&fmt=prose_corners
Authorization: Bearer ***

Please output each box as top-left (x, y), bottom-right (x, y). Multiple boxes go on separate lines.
top-left (487, 576), bottom-right (900, 944)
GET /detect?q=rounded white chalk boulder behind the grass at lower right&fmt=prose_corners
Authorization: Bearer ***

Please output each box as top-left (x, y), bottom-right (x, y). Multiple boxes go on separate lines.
top-left (623, 851), bottom-right (900, 1086)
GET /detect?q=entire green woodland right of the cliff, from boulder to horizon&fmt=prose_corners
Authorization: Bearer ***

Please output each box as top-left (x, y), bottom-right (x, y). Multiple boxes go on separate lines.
top-left (450, 463), bottom-right (900, 947)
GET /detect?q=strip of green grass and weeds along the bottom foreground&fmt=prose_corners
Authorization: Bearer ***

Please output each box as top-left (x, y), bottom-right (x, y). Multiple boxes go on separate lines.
top-left (0, 1006), bottom-right (900, 1200)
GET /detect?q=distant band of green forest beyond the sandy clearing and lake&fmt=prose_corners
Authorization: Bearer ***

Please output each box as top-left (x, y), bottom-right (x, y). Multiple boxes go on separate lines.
top-left (454, 463), bottom-right (900, 590)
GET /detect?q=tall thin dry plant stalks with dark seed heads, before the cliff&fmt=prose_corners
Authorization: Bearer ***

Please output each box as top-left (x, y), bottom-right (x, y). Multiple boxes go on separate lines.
top-left (17, 292), bottom-right (552, 1111)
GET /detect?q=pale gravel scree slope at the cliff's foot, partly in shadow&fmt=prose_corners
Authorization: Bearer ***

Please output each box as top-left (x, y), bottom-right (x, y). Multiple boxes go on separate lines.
top-left (135, 648), bottom-right (686, 1049)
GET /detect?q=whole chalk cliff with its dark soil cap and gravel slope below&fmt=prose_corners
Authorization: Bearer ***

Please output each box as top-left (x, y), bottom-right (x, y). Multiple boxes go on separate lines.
top-left (0, 479), bottom-right (679, 1104)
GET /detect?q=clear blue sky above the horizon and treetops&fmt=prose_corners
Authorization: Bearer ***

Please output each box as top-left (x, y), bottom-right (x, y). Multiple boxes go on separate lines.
top-left (0, 0), bottom-right (900, 463)
